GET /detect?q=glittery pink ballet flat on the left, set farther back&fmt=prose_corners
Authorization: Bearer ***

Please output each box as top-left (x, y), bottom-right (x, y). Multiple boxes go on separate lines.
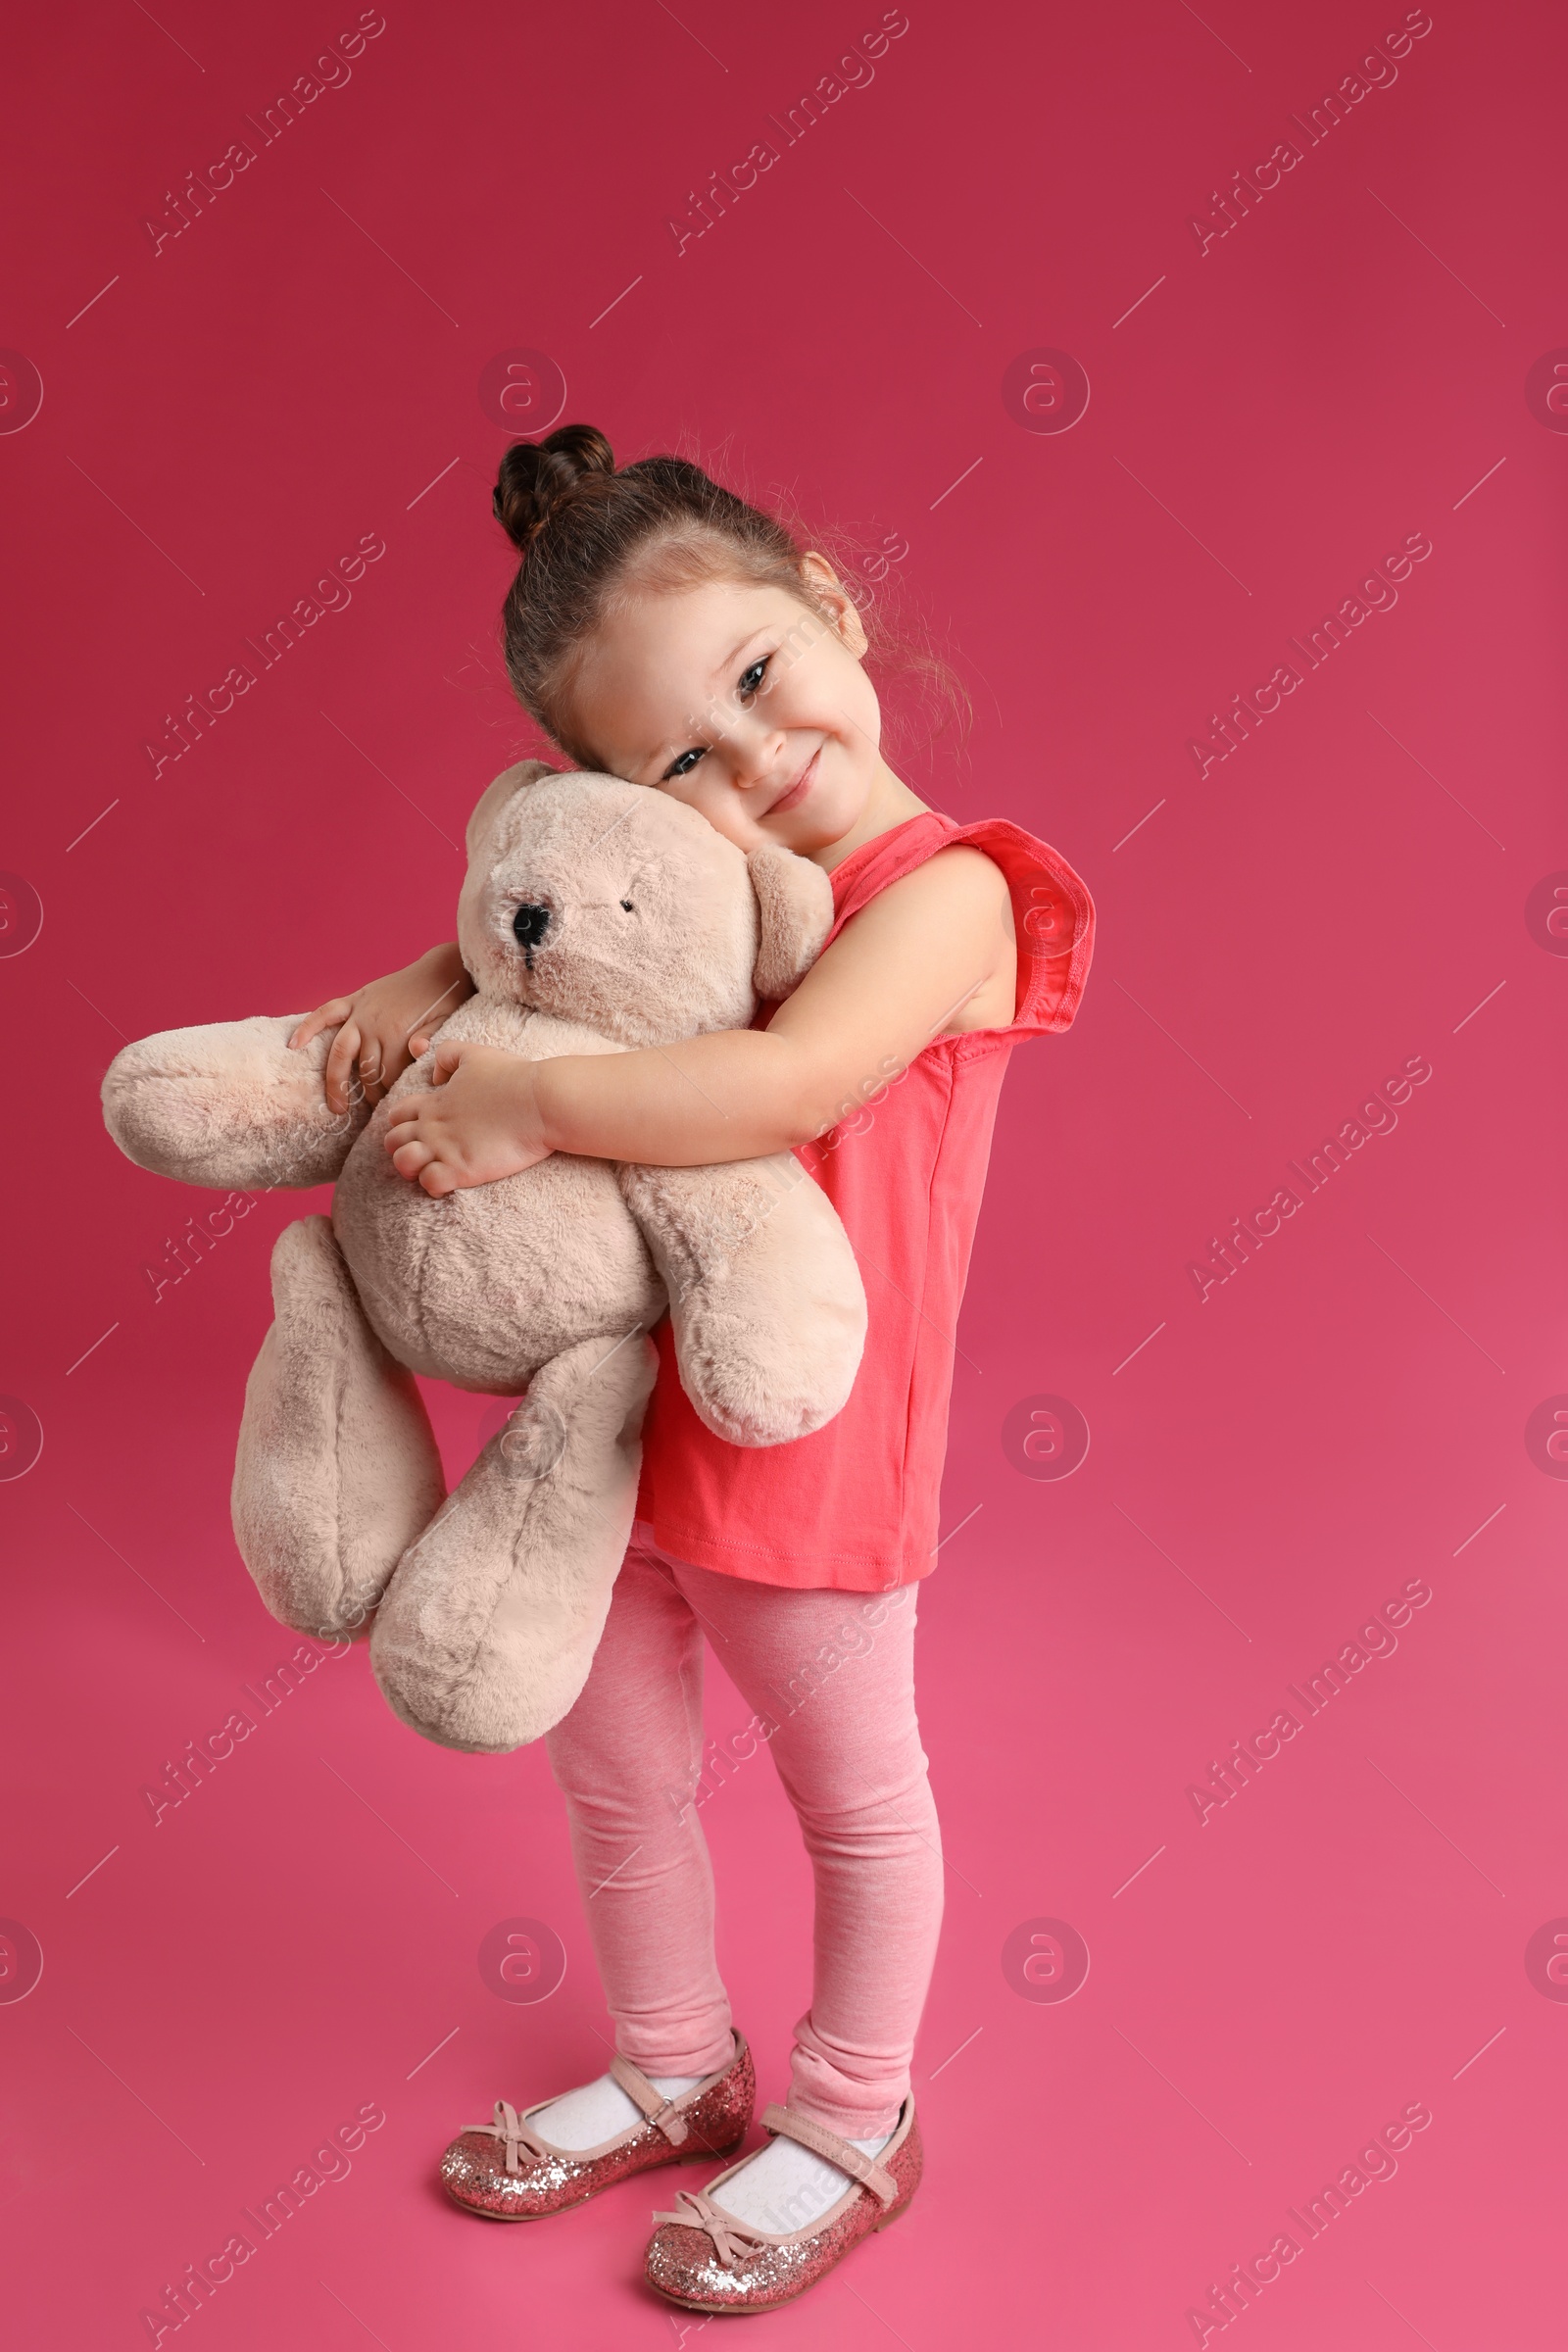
top-left (442, 2028), bottom-right (757, 2221)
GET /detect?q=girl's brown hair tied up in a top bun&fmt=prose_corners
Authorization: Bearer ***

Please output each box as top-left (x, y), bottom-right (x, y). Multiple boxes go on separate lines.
top-left (491, 425), bottom-right (968, 766)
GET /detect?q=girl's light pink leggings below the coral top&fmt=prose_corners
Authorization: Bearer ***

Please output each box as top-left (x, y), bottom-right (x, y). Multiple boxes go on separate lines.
top-left (548, 1524), bottom-right (943, 2140)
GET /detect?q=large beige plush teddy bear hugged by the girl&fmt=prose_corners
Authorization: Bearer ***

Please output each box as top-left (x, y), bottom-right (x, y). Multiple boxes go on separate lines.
top-left (104, 760), bottom-right (865, 1752)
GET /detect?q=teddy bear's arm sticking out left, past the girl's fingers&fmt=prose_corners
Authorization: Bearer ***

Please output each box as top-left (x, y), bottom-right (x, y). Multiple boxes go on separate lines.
top-left (104, 1013), bottom-right (371, 1188)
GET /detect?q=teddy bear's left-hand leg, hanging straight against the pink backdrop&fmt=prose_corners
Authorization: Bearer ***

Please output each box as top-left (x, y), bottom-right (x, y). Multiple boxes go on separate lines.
top-left (232, 1216), bottom-right (447, 1640)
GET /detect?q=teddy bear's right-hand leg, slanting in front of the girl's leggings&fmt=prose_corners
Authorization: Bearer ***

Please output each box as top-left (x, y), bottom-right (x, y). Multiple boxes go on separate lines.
top-left (371, 1331), bottom-right (659, 1754)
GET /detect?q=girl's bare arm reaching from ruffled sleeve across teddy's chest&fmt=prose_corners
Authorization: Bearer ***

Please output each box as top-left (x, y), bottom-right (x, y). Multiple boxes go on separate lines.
top-left (385, 845), bottom-right (1018, 1195)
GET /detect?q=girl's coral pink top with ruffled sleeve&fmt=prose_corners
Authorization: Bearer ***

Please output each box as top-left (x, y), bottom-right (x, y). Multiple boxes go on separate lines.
top-left (637, 809), bottom-right (1093, 1592)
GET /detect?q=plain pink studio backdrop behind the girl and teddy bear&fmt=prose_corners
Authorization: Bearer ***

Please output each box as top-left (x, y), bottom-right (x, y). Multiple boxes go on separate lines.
top-left (0, 0), bottom-right (1568, 2352)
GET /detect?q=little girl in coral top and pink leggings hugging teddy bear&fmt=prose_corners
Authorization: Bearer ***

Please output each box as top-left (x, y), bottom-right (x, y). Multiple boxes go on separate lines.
top-left (294, 425), bottom-right (1093, 2312)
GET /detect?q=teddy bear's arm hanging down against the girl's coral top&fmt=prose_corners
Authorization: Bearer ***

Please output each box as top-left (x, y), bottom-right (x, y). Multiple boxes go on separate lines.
top-left (615, 1152), bottom-right (865, 1446)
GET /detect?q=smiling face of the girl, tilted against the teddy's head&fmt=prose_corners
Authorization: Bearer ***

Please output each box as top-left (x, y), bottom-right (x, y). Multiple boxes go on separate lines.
top-left (571, 555), bottom-right (882, 857)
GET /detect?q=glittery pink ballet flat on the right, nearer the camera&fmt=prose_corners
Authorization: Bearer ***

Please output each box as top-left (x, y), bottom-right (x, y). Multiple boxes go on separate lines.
top-left (647, 2098), bottom-right (924, 2312)
